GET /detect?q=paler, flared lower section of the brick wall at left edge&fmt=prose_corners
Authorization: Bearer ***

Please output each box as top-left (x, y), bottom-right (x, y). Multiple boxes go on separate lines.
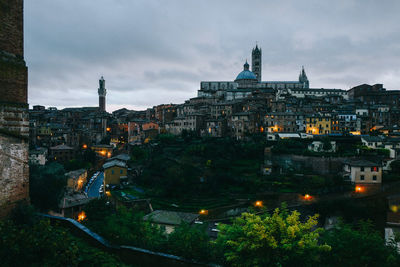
top-left (0, 133), bottom-right (29, 217)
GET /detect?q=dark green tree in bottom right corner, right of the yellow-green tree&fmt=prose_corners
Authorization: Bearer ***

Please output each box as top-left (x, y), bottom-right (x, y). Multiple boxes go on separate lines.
top-left (321, 221), bottom-right (400, 267)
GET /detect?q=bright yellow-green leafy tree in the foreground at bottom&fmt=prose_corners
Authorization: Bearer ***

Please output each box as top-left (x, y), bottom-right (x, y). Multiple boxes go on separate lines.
top-left (216, 207), bottom-right (330, 266)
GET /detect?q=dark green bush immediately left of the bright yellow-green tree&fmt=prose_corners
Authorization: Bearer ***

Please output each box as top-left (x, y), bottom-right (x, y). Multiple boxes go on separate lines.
top-left (167, 224), bottom-right (212, 262)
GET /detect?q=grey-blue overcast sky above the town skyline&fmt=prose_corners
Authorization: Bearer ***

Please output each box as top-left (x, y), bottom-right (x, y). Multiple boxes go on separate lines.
top-left (25, 0), bottom-right (400, 112)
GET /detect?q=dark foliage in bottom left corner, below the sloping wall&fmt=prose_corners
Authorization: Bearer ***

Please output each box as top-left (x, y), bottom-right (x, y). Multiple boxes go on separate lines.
top-left (0, 217), bottom-right (123, 266)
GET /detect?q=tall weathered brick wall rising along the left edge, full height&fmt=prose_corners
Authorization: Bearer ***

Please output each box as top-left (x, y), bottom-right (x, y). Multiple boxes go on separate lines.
top-left (0, 0), bottom-right (29, 216)
